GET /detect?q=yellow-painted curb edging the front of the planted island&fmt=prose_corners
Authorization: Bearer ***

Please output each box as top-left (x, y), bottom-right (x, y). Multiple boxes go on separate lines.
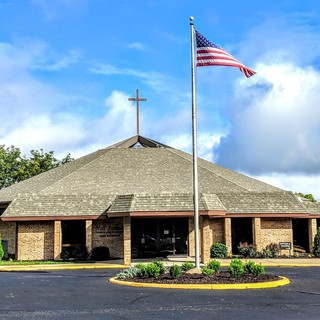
top-left (109, 277), bottom-right (290, 290)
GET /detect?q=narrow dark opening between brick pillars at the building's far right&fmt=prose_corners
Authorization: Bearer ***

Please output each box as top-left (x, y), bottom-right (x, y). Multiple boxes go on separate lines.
top-left (292, 219), bottom-right (309, 253)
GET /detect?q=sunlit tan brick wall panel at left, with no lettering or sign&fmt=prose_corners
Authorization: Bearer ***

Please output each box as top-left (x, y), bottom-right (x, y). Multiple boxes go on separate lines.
top-left (17, 221), bottom-right (54, 260)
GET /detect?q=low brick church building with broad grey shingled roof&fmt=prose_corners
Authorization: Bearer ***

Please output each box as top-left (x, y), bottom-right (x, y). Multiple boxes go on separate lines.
top-left (0, 134), bottom-right (320, 264)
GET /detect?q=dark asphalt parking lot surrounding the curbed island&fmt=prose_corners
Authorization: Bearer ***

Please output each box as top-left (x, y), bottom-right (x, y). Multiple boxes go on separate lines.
top-left (0, 267), bottom-right (320, 320)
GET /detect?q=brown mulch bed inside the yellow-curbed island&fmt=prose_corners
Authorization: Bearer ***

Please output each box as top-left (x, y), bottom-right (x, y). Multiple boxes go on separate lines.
top-left (119, 271), bottom-right (280, 284)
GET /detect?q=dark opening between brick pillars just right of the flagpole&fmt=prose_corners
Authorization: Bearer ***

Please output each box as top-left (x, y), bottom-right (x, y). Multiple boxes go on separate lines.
top-left (231, 218), bottom-right (253, 253)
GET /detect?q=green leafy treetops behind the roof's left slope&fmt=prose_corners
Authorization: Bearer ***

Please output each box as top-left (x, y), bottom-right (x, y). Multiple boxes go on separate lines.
top-left (0, 145), bottom-right (73, 189)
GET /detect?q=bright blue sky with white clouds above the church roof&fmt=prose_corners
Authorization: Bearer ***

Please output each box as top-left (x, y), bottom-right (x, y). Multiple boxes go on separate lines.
top-left (0, 0), bottom-right (320, 199)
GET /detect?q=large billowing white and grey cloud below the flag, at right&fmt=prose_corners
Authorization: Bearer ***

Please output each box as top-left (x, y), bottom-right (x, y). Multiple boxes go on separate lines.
top-left (218, 62), bottom-right (320, 174)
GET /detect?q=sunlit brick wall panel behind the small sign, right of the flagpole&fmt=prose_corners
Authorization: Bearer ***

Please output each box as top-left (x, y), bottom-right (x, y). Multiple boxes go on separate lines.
top-left (259, 218), bottom-right (293, 254)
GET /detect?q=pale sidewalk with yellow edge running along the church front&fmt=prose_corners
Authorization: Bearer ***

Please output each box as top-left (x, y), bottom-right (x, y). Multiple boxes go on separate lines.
top-left (0, 257), bottom-right (320, 272)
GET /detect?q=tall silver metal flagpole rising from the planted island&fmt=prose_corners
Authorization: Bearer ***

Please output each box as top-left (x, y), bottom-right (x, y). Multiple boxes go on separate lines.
top-left (189, 17), bottom-right (200, 269)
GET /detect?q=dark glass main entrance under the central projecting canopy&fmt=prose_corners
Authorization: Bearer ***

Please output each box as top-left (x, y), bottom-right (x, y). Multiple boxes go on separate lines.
top-left (131, 218), bottom-right (188, 258)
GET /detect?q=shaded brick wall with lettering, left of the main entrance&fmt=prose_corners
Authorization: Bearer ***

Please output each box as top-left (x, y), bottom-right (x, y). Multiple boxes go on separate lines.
top-left (92, 218), bottom-right (123, 258)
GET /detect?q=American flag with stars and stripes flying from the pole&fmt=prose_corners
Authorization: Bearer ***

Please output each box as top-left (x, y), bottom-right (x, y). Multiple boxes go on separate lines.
top-left (195, 30), bottom-right (256, 78)
